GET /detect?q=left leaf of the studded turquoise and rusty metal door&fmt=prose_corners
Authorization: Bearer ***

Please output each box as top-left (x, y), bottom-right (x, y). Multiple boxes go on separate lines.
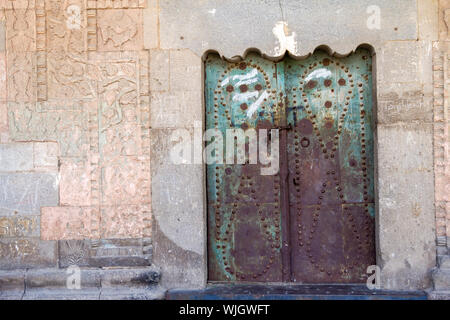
top-left (205, 55), bottom-right (282, 282)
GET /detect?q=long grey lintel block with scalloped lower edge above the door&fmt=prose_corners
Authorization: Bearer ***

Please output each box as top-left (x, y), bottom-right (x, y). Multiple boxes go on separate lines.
top-left (159, 0), bottom-right (417, 58)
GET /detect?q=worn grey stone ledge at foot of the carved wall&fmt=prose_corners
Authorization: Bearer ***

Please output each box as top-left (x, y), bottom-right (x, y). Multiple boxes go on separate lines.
top-left (0, 266), bottom-right (165, 300)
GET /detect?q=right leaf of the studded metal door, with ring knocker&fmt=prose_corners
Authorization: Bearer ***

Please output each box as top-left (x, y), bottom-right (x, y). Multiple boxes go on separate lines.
top-left (285, 50), bottom-right (375, 283)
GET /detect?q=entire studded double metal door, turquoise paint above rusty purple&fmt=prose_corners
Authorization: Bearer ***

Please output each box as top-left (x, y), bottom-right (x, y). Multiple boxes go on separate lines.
top-left (205, 49), bottom-right (375, 283)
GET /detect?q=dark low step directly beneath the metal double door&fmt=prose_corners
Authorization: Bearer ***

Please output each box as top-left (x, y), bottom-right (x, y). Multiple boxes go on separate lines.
top-left (166, 284), bottom-right (427, 300)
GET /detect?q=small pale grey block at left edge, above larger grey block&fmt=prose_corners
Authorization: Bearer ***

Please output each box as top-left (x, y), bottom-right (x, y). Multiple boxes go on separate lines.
top-left (0, 143), bottom-right (33, 172)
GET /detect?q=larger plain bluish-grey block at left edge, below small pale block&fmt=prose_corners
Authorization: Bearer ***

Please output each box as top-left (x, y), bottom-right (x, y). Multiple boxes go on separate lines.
top-left (0, 173), bottom-right (58, 215)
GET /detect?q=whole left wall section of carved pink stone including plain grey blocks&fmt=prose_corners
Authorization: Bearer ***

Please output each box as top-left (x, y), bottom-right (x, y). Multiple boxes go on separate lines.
top-left (0, 0), bottom-right (151, 268)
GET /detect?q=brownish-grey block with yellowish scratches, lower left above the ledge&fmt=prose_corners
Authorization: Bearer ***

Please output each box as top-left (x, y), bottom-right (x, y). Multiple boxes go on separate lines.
top-left (0, 238), bottom-right (57, 270)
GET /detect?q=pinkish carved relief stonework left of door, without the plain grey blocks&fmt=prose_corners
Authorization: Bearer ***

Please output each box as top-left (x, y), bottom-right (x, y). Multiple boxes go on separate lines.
top-left (0, 0), bottom-right (151, 242)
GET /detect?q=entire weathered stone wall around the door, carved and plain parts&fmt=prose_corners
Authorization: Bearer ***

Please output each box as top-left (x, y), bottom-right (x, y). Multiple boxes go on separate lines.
top-left (0, 0), bottom-right (444, 296)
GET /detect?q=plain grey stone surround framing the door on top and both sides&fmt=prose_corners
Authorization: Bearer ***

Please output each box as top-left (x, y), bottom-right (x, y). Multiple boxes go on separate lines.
top-left (144, 0), bottom-right (438, 289)
